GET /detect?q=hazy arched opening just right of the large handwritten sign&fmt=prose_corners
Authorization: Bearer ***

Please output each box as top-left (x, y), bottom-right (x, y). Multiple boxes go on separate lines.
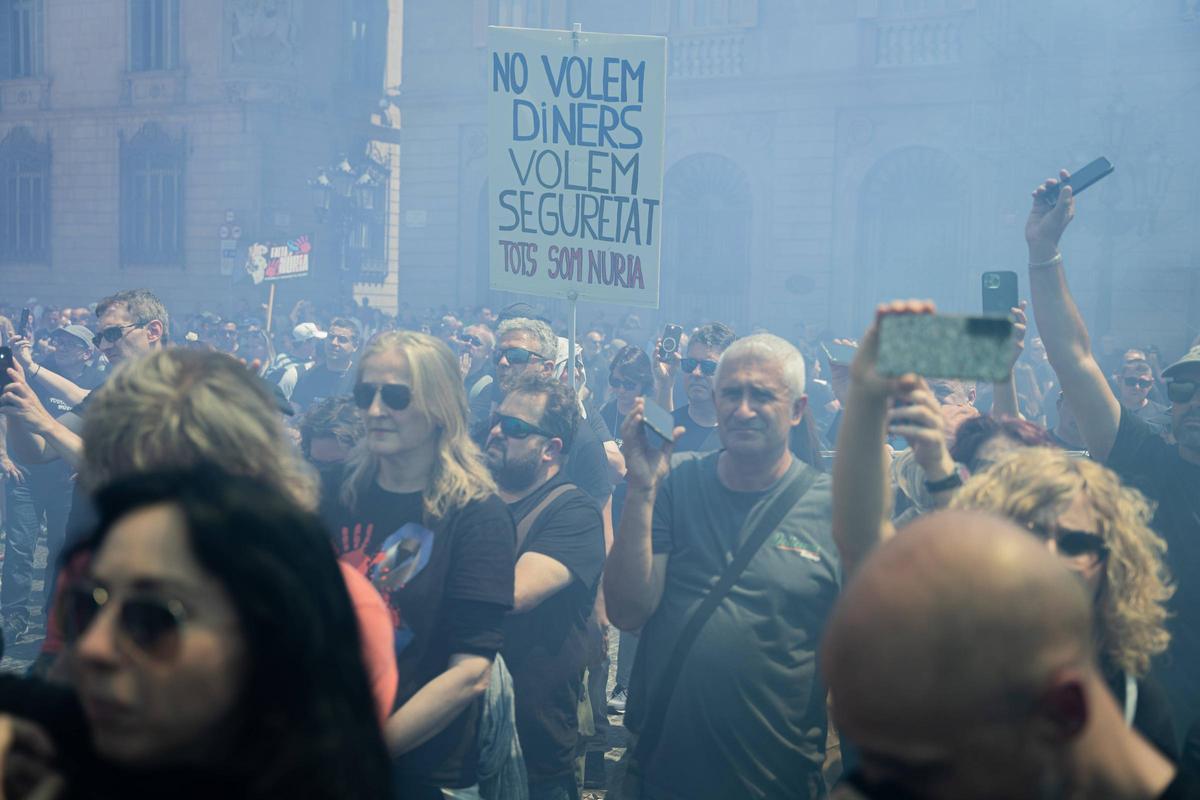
top-left (659, 154), bottom-right (754, 327)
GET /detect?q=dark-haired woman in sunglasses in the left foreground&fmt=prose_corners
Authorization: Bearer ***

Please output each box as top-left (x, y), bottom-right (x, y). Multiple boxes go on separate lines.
top-left (0, 464), bottom-right (390, 800)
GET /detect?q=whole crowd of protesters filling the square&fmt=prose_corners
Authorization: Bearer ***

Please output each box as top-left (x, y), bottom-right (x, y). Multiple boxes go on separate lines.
top-left (0, 173), bottom-right (1200, 800)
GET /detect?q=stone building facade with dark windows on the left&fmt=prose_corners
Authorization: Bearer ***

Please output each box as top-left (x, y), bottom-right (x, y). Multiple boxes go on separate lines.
top-left (0, 0), bottom-right (401, 319)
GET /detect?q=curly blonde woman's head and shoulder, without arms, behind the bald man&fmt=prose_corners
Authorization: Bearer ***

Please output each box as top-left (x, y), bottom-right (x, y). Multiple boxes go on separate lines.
top-left (949, 447), bottom-right (1178, 760)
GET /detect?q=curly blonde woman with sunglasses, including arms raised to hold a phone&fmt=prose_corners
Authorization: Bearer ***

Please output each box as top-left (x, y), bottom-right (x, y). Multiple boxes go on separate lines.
top-left (833, 301), bottom-right (1178, 758)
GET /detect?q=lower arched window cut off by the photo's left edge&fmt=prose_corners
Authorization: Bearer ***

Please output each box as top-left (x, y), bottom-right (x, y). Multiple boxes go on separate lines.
top-left (0, 127), bottom-right (50, 264)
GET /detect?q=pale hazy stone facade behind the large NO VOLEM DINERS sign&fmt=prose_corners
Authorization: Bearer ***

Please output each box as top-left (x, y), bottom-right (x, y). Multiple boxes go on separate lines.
top-left (398, 0), bottom-right (1200, 349)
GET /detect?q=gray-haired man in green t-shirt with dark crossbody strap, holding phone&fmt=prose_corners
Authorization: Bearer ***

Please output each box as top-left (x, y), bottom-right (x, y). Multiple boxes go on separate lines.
top-left (604, 333), bottom-right (841, 800)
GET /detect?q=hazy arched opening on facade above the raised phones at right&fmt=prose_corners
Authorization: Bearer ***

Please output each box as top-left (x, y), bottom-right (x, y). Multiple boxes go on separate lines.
top-left (854, 148), bottom-right (973, 323)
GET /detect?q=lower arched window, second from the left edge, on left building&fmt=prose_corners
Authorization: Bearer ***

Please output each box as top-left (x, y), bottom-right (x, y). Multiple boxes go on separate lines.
top-left (121, 122), bottom-right (184, 265)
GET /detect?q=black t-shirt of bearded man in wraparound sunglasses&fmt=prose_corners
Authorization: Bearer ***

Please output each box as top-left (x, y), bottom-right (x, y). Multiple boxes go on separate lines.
top-left (504, 476), bottom-right (605, 781)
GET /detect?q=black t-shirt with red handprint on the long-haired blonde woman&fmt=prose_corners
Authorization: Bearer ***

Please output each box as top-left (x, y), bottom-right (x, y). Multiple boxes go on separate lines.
top-left (322, 475), bottom-right (516, 796)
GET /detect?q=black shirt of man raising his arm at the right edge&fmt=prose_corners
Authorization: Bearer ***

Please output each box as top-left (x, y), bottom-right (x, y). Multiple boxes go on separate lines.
top-left (1108, 408), bottom-right (1200, 729)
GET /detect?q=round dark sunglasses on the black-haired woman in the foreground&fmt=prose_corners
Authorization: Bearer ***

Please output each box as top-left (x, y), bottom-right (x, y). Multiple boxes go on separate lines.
top-left (61, 585), bottom-right (187, 661)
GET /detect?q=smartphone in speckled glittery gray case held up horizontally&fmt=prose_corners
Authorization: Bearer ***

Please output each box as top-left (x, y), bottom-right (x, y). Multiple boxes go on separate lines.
top-left (877, 314), bottom-right (1013, 384)
